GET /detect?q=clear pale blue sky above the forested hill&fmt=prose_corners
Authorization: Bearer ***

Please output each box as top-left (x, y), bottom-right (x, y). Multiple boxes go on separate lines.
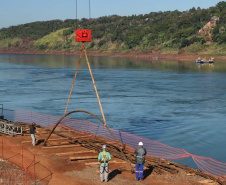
top-left (0, 0), bottom-right (220, 28)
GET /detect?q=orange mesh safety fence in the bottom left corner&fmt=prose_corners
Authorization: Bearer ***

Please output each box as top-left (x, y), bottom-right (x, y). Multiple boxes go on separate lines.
top-left (0, 136), bottom-right (52, 185)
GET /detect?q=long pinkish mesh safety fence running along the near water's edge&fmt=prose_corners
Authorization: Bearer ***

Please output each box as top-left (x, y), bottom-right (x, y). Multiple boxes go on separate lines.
top-left (0, 110), bottom-right (226, 181)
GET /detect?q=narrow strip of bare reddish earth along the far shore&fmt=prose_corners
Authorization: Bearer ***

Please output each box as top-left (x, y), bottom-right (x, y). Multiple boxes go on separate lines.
top-left (0, 50), bottom-right (226, 62)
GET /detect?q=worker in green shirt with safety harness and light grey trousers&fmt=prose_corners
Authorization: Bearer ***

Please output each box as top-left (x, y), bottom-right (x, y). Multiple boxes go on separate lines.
top-left (98, 145), bottom-right (111, 182)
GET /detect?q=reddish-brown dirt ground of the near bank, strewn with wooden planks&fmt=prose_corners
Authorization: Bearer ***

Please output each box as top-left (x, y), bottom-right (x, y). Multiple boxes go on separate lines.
top-left (0, 121), bottom-right (223, 185)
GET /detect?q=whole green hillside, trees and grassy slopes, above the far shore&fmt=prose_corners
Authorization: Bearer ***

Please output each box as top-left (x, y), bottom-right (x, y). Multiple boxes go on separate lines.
top-left (0, 1), bottom-right (226, 54)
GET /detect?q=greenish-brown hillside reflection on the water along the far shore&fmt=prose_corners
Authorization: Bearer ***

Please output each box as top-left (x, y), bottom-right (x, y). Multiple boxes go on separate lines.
top-left (0, 54), bottom-right (226, 73)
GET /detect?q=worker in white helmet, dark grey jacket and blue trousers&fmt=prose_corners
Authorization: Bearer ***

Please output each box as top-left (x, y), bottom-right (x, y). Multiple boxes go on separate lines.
top-left (134, 142), bottom-right (147, 180)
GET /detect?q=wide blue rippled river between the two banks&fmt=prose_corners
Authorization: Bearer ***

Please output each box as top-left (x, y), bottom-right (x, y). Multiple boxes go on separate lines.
top-left (0, 54), bottom-right (226, 163)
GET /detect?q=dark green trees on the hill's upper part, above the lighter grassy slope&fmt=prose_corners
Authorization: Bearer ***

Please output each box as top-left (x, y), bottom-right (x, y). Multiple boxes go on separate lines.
top-left (0, 1), bottom-right (226, 49)
